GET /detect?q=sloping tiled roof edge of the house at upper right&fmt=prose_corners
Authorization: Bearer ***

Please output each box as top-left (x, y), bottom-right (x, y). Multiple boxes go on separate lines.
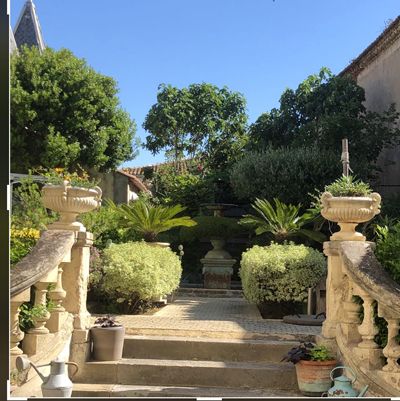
top-left (339, 15), bottom-right (400, 78)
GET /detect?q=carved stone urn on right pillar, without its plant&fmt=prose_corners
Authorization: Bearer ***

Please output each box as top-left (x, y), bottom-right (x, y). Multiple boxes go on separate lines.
top-left (321, 192), bottom-right (381, 241)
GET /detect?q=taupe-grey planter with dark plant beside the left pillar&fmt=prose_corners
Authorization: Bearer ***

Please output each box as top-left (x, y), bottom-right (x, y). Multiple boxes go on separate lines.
top-left (90, 315), bottom-right (125, 361)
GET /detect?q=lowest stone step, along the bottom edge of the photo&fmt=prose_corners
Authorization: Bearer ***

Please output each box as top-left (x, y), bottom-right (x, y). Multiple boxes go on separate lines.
top-left (72, 383), bottom-right (301, 398)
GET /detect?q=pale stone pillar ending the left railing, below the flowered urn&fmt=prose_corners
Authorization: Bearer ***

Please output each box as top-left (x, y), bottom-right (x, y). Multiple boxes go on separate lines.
top-left (62, 231), bottom-right (93, 330)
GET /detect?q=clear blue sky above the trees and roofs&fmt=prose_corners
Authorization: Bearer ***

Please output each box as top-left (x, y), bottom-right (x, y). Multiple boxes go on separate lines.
top-left (10, 0), bottom-right (400, 166)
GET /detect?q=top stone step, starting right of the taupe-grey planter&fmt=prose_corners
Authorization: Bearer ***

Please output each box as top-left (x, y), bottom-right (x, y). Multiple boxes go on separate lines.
top-left (123, 335), bottom-right (298, 362)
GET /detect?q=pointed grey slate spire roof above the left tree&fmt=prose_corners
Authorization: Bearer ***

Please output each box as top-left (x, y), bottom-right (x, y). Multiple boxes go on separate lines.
top-left (14, 0), bottom-right (46, 51)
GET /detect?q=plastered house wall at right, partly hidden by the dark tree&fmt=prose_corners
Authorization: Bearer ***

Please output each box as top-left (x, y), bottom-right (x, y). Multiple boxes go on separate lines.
top-left (356, 39), bottom-right (400, 195)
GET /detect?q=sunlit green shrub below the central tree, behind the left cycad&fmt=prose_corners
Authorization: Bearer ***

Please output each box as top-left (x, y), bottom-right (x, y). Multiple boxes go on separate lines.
top-left (153, 162), bottom-right (212, 213)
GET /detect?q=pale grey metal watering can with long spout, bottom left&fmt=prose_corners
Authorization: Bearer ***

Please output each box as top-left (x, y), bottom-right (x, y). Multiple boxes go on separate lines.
top-left (15, 356), bottom-right (78, 397)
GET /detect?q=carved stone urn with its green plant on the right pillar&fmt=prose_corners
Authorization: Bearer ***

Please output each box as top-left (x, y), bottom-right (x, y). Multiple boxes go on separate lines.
top-left (321, 175), bottom-right (381, 241)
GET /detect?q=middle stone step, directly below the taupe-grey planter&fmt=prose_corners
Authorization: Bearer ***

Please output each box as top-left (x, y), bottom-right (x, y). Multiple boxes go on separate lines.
top-left (80, 358), bottom-right (297, 390)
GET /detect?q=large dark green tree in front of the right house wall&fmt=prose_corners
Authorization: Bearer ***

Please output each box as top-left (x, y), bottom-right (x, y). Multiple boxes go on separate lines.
top-left (249, 68), bottom-right (400, 170)
